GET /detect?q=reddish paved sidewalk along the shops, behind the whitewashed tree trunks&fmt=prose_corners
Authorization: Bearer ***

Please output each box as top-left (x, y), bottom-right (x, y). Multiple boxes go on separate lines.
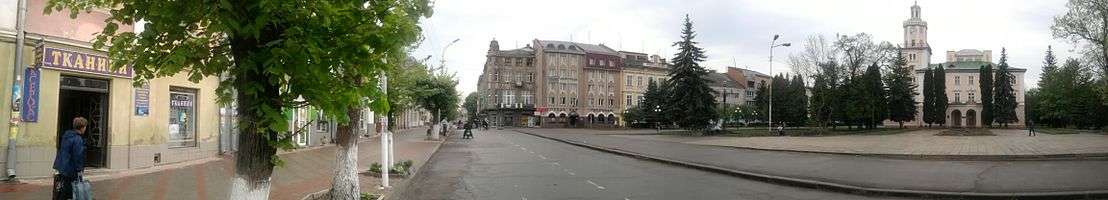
top-left (0, 128), bottom-right (441, 200)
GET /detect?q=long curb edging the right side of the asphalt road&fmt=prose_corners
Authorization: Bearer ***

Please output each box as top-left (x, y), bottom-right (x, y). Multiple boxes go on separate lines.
top-left (513, 129), bottom-right (1108, 199)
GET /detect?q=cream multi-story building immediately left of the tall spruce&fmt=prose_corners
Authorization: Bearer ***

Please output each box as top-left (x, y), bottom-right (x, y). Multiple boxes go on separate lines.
top-left (616, 51), bottom-right (669, 124)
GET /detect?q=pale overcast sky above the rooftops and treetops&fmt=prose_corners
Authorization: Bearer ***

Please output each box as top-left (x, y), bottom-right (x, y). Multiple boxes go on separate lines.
top-left (414, 0), bottom-right (1075, 95)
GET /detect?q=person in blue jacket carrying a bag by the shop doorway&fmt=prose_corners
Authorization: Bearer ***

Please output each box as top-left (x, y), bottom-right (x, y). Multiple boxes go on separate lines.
top-left (53, 117), bottom-right (89, 200)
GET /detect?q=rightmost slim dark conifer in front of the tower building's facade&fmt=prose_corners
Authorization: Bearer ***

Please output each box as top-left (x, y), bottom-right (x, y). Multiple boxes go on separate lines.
top-left (993, 48), bottom-right (1019, 127)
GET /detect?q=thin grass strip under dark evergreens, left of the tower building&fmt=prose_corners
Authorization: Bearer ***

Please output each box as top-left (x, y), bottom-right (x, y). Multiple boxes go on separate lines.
top-left (719, 127), bottom-right (917, 137)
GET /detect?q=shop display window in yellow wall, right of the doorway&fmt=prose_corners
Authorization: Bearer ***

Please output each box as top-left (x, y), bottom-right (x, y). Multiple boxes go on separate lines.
top-left (167, 87), bottom-right (196, 147)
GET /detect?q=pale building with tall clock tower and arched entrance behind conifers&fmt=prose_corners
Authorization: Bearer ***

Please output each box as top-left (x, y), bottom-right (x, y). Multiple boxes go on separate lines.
top-left (904, 4), bottom-right (1027, 127)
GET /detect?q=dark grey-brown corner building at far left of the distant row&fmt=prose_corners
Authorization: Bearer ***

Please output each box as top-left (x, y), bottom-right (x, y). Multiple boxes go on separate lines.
top-left (478, 40), bottom-right (537, 126)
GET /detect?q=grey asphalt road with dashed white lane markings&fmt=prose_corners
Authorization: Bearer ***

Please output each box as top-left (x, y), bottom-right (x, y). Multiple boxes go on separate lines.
top-left (397, 130), bottom-right (894, 200)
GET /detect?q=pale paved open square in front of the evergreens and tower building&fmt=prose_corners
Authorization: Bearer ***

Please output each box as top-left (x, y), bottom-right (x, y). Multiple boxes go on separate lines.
top-left (604, 129), bottom-right (1108, 156)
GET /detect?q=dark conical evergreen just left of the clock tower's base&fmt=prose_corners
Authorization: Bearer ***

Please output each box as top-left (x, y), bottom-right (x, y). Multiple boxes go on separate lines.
top-left (884, 50), bottom-right (919, 128)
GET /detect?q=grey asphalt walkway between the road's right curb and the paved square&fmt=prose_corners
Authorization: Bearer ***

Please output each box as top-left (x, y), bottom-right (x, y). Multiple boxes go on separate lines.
top-left (517, 129), bottom-right (1108, 196)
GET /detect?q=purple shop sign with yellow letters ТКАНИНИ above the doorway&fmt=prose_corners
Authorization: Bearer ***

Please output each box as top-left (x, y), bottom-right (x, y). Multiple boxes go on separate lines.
top-left (37, 48), bottom-right (132, 78)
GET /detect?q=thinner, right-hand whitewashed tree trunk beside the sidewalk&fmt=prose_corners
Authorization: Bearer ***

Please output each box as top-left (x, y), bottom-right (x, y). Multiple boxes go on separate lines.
top-left (329, 107), bottom-right (361, 200)
